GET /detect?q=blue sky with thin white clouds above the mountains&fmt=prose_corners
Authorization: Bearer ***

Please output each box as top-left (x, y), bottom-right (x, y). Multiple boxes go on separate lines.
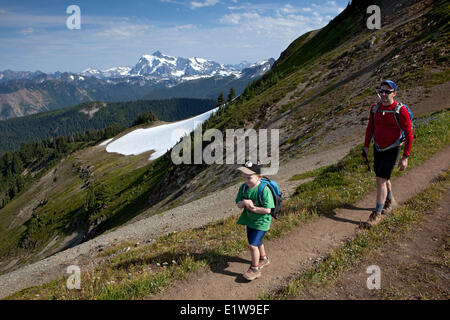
top-left (0, 0), bottom-right (348, 72)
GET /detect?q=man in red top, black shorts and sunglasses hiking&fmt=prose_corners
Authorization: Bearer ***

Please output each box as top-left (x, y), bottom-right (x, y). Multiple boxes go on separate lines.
top-left (364, 80), bottom-right (413, 226)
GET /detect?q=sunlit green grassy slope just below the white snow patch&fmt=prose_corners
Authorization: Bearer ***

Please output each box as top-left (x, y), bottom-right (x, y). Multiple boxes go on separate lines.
top-left (0, 151), bottom-right (170, 259)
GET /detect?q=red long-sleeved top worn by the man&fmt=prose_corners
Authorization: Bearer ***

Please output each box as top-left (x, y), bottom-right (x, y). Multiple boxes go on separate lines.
top-left (364, 101), bottom-right (413, 156)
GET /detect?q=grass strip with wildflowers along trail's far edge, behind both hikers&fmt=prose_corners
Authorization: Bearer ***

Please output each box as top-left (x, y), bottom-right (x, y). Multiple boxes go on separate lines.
top-left (5, 110), bottom-right (450, 299)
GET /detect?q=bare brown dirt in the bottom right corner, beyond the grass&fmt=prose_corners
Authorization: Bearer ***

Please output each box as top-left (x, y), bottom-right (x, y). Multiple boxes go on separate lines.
top-left (308, 188), bottom-right (450, 300)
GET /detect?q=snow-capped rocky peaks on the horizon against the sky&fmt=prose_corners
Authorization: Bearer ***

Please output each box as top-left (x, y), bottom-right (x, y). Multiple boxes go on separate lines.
top-left (81, 51), bottom-right (273, 82)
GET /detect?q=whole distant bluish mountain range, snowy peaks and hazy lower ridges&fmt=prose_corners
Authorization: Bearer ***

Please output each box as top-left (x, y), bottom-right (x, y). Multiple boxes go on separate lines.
top-left (0, 51), bottom-right (275, 120)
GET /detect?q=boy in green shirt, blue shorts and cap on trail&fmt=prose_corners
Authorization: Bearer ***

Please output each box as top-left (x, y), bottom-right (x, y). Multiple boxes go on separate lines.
top-left (236, 161), bottom-right (275, 280)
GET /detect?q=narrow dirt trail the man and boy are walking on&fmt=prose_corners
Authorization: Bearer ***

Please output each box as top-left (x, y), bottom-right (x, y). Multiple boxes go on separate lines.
top-left (148, 146), bottom-right (450, 300)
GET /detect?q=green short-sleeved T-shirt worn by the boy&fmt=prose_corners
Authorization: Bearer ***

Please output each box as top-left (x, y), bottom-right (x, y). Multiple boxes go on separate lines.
top-left (236, 182), bottom-right (275, 231)
